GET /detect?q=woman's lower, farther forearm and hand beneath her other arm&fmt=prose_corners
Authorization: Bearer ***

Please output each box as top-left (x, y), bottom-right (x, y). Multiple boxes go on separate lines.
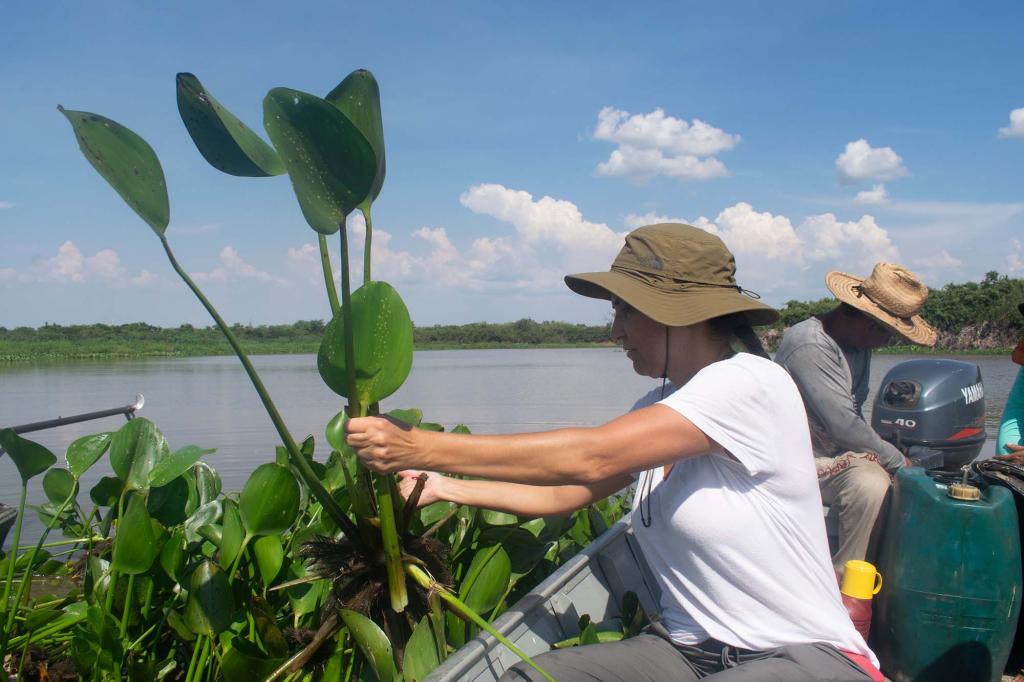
top-left (398, 470), bottom-right (633, 516)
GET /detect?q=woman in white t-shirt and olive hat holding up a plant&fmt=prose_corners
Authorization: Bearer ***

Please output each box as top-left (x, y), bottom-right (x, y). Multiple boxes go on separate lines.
top-left (347, 223), bottom-right (882, 682)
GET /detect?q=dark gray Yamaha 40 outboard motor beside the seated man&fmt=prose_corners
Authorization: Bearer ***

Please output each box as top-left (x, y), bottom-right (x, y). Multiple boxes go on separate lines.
top-left (871, 359), bottom-right (985, 471)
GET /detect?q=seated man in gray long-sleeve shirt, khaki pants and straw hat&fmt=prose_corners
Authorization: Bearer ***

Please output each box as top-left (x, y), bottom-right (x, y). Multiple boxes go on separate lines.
top-left (775, 263), bottom-right (937, 574)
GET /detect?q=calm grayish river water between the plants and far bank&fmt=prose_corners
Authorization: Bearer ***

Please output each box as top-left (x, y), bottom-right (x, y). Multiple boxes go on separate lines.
top-left (0, 348), bottom-right (1017, 542)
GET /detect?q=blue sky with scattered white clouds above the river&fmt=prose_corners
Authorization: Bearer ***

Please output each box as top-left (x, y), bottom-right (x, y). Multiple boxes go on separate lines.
top-left (0, 1), bottom-right (1024, 327)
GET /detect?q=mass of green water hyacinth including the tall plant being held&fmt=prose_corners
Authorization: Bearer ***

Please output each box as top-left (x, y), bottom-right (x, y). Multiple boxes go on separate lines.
top-left (0, 70), bottom-right (623, 682)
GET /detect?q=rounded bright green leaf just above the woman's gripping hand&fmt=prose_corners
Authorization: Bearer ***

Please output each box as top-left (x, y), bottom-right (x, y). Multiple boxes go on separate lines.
top-left (316, 282), bottom-right (413, 404)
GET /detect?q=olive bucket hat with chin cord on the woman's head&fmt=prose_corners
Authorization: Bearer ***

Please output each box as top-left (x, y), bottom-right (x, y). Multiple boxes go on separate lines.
top-left (565, 222), bottom-right (778, 327)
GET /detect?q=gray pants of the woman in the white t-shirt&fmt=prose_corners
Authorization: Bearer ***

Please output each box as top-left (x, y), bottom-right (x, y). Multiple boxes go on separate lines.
top-left (501, 626), bottom-right (871, 682)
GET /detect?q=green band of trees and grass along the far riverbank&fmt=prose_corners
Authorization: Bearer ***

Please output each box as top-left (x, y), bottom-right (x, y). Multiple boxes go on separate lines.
top-left (0, 272), bottom-right (1024, 361)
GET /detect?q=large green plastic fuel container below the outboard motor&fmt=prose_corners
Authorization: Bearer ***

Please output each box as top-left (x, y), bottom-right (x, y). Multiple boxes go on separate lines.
top-left (871, 467), bottom-right (1021, 682)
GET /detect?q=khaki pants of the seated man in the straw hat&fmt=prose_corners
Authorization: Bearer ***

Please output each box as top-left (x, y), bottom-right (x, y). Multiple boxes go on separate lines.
top-left (814, 453), bottom-right (892, 577)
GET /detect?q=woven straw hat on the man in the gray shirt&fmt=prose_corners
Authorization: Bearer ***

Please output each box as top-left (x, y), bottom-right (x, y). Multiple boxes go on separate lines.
top-left (825, 263), bottom-right (939, 346)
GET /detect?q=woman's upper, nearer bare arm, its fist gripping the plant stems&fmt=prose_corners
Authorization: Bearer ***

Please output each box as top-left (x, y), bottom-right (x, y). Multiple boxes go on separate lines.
top-left (346, 404), bottom-right (722, 485)
